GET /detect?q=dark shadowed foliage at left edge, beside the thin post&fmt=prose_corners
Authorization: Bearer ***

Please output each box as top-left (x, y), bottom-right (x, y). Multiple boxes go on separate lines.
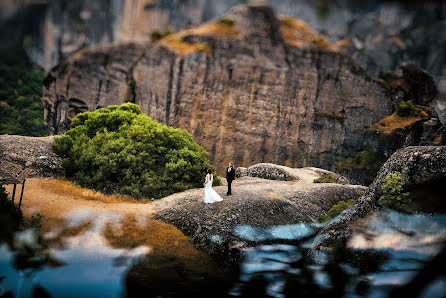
top-left (0, 185), bottom-right (22, 242)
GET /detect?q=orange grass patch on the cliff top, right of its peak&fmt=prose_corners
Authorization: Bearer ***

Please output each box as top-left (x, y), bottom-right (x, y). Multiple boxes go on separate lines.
top-left (279, 16), bottom-right (339, 52)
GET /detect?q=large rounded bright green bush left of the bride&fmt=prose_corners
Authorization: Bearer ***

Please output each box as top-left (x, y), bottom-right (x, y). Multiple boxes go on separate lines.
top-left (53, 103), bottom-right (219, 198)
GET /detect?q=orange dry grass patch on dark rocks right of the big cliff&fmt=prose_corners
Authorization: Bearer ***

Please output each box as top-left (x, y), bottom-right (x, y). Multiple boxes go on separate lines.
top-left (368, 111), bottom-right (429, 134)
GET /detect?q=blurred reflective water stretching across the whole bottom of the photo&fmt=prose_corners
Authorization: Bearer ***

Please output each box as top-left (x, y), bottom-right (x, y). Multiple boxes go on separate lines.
top-left (0, 211), bottom-right (446, 297)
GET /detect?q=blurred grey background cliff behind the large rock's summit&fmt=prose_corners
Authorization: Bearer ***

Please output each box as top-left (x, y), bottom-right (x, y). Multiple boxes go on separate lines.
top-left (0, 0), bottom-right (446, 123)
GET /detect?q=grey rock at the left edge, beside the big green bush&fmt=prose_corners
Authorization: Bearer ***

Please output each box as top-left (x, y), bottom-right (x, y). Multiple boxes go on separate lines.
top-left (0, 135), bottom-right (64, 177)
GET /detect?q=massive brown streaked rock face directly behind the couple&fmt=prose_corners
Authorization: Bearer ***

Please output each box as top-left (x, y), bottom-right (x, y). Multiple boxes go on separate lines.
top-left (44, 5), bottom-right (400, 175)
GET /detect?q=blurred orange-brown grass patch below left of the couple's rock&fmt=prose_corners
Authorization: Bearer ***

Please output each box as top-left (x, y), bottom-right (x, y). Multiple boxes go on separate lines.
top-left (104, 215), bottom-right (218, 272)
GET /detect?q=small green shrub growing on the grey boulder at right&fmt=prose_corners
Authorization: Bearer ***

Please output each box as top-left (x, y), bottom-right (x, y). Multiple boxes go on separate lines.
top-left (378, 172), bottom-right (410, 209)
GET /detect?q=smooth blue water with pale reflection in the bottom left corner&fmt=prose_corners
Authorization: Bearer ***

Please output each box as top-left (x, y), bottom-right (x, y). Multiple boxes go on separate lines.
top-left (0, 230), bottom-right (150, 297)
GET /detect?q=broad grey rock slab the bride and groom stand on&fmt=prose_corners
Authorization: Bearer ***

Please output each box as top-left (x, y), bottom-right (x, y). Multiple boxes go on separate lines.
top-left (152, 165), bottom-right (366, 263)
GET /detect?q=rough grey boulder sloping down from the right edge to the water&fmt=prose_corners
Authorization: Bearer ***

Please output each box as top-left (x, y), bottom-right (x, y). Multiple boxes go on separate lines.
top-left (313, 146), bottom-right (446, 255)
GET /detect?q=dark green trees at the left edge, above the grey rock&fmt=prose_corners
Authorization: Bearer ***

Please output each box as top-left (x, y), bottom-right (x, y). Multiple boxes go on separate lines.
top-left (0, 47), bottom-right (49, 136)
